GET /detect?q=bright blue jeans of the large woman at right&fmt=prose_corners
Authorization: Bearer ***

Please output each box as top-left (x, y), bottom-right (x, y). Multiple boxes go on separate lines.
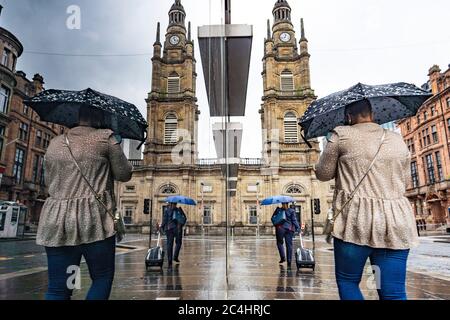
top-left (334, 238), bottom-right (409, 300)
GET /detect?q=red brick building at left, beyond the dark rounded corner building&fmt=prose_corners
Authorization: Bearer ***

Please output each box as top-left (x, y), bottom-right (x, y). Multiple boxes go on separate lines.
top-left (0, 71), bottom-right (65, 222)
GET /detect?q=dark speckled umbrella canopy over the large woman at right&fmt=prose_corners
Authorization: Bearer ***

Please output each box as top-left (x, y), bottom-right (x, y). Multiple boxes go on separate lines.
top-left (299, 82), bottom-right (432, 139)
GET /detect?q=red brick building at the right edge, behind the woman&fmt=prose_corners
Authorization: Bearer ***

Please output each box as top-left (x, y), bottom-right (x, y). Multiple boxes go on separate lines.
top-left (398, 65), bottom-right (450, 227)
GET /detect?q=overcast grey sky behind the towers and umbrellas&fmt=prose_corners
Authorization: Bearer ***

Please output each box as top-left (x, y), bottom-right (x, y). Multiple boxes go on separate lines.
top-left (0, 0), bottom-right (450, 158)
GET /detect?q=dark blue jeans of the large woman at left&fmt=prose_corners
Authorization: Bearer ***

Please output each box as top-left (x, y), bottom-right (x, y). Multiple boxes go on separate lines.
top-left (45, 236), bottom-right (116, 300)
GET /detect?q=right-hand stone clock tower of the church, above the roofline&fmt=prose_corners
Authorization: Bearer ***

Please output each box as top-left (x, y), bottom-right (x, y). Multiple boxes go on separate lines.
top-left (260, 0), bottom-right (320, 166)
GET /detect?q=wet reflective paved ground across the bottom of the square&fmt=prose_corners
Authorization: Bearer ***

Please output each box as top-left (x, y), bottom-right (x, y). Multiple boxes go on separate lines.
top-left (0, 236), bottom-right (450, 300)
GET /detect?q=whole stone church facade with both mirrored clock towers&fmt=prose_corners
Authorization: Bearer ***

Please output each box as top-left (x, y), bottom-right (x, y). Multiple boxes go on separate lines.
top-left (116, 0), bottom-right (334, 235)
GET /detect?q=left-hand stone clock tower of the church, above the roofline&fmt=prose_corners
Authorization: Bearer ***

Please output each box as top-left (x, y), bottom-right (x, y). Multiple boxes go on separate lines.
top-left (144, 0), bottom-right (200, 166)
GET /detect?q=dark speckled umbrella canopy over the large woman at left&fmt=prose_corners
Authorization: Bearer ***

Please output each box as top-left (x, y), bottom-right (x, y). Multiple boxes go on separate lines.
top-left (24, 88), bottom-right (148, 141)
